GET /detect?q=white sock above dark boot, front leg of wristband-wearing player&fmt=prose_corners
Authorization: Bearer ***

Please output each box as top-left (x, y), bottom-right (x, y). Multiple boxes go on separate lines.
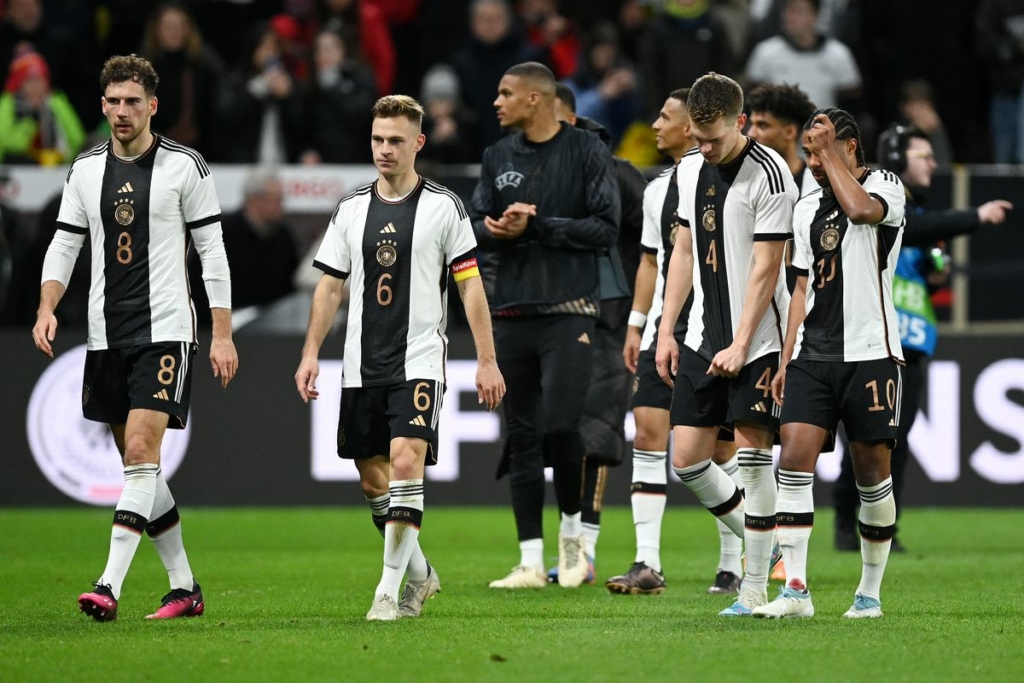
top-left (630, 449), bottom-right (669, 571)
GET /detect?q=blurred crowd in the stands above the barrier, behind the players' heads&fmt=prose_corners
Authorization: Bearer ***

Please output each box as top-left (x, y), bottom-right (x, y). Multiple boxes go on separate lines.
top-left (0, 0), bottom-right (1024, 166)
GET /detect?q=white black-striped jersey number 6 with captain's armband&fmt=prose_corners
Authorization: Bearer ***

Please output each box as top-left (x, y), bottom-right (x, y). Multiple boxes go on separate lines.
top-left (313, 178), bottom-right (478, 387)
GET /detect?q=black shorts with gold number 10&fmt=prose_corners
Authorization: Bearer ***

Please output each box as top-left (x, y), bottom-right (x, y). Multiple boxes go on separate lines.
top-left (781, 356), bottom-right (903, 453)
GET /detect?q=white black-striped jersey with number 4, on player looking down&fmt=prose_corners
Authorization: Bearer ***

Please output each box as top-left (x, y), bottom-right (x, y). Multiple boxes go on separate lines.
top-left (679, 139), bottom-right (798, 361)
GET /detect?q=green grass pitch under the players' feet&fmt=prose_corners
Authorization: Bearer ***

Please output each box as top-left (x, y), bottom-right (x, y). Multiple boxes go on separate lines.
top-left (0, 505), bottom-right (1024, 683)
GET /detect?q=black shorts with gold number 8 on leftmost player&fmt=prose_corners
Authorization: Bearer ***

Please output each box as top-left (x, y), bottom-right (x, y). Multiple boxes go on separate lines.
top-left (82, 342), bottom-right (197, 429)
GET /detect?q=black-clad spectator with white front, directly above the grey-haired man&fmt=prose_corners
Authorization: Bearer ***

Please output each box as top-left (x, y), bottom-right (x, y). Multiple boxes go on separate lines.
top-left (207, 22), bottom-right (308, 165)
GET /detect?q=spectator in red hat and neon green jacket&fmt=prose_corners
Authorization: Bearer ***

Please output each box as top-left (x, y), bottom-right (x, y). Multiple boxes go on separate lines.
top-left (0, 52), bottom-right (85, 166)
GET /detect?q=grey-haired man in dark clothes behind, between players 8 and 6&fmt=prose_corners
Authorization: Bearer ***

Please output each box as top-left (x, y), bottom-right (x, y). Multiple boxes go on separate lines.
top-left (189, 168), bottom-right (299, 310)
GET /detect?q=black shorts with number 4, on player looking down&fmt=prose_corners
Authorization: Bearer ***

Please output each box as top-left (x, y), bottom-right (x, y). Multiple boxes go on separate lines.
top-left (669, 346), bottom-right (779, 432)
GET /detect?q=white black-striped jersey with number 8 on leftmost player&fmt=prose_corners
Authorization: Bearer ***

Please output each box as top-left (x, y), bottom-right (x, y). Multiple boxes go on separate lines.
top-left (57, 136), bottom-right (229, 350)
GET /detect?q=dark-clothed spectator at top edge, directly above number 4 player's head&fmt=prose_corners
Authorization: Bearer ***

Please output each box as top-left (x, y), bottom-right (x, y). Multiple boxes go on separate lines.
top-left (637, 0), bottom-right (739, 118)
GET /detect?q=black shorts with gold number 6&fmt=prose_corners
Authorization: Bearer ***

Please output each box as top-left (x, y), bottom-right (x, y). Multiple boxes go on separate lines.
top-left (338, 380), bottom-right (444, 465)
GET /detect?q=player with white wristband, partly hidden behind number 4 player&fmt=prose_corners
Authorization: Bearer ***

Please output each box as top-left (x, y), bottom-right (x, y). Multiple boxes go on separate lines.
top-left (605, 88), bottom-right (743, 595)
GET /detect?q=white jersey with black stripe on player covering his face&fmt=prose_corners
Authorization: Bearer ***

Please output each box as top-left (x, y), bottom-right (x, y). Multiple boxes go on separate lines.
top-left (793, 170), bottom-right (906, 362)
